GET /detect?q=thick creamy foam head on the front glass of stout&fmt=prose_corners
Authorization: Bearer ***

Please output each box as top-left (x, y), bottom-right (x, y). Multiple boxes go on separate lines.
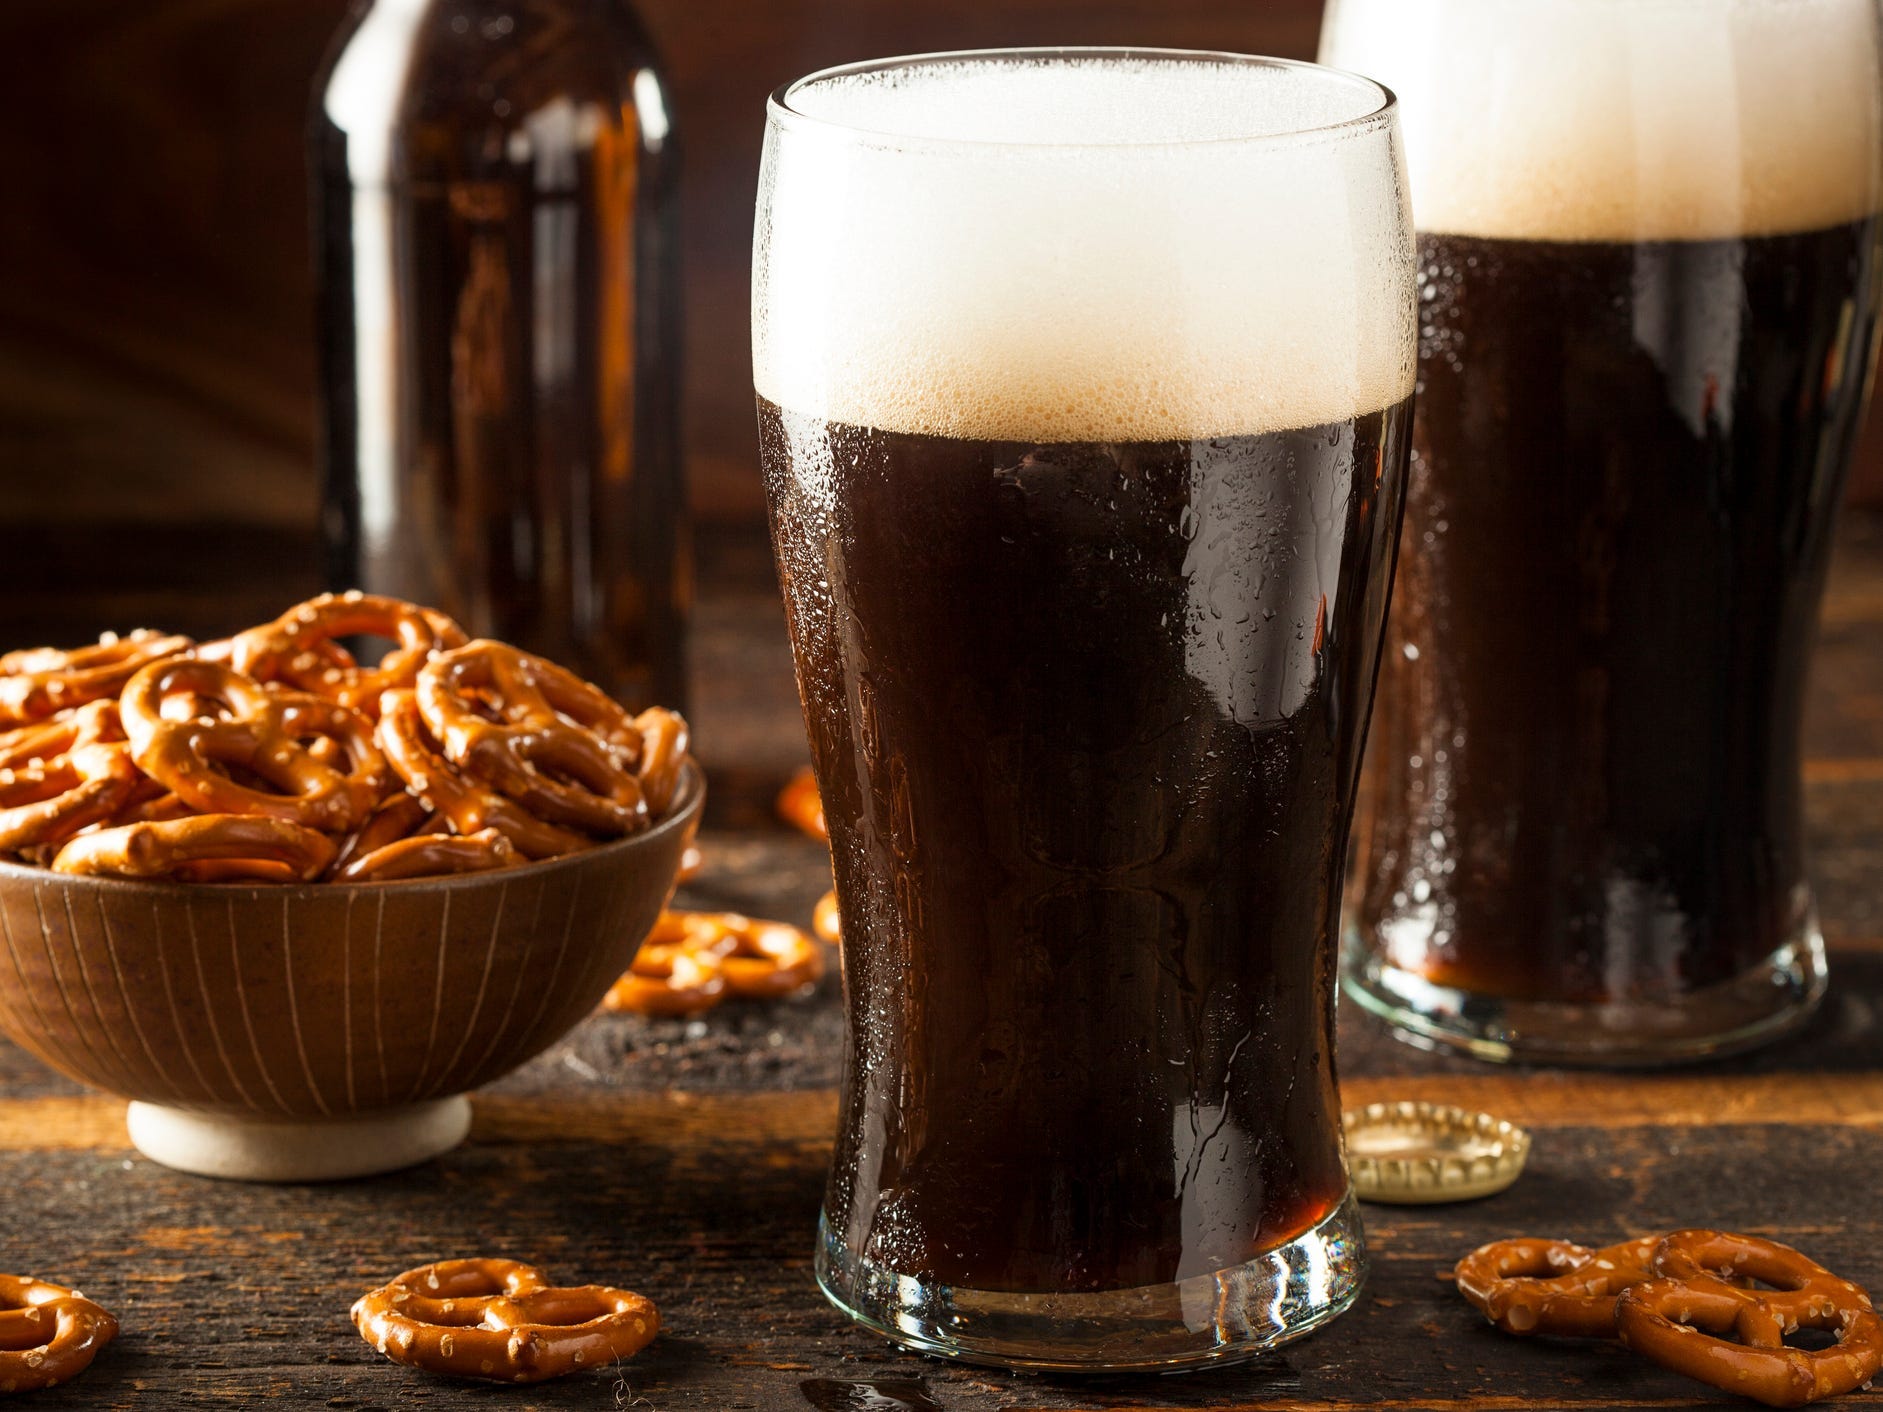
top-left (753, 55), bottom-right (1414, 441)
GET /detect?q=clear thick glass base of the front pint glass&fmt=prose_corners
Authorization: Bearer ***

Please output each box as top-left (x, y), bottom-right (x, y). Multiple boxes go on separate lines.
top-left (817, 1195), bottom-right (1367, 1372)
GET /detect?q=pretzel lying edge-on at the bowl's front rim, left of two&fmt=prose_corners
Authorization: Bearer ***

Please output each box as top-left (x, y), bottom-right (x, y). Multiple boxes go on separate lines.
top-left (53, 813), bottom-right (333, 883)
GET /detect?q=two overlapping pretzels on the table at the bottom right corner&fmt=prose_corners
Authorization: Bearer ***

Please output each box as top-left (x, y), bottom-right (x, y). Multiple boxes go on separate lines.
top-left (1452, 1229), bottom-right (1883, 1406)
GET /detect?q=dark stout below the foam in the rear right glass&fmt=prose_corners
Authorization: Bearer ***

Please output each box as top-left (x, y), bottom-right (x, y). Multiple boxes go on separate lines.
top-left (1356, 220), bottom-right (1877, 1002)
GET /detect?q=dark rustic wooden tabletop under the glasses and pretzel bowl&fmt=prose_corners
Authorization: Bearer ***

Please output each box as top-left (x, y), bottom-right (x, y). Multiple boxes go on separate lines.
top-left (0, 518), bottom-right (1883, 1412)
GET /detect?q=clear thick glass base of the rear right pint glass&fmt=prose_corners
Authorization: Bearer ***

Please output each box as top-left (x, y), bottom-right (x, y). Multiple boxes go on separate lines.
top-left (1341, 921), bottom-right (1828, 1067)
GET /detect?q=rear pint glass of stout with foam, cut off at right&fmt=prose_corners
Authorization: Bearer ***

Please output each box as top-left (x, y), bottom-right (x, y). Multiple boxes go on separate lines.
top-left (1322, 0), bottom-right (1883, 1064)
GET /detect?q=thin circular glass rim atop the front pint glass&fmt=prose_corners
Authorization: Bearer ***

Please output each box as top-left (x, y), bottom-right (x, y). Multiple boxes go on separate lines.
top-left (764, 45), bottom-right (1399, 152)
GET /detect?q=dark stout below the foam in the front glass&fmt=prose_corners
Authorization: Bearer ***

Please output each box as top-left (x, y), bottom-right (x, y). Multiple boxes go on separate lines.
top-left (761, 403), bottom-right (1410, 1290)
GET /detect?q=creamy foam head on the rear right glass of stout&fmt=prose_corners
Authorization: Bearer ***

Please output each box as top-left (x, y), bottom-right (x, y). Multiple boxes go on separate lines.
top-left (1320, 0), bottom-right (1883, 241)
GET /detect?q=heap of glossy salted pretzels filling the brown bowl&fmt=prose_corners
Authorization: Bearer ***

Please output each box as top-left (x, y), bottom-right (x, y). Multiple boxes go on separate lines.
top-left (0, 593), bottom-right (687, 883)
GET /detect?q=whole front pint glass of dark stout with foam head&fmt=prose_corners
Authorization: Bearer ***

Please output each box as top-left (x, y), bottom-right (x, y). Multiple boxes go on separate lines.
top-left (753, 51), bottom-right (1416, 1369)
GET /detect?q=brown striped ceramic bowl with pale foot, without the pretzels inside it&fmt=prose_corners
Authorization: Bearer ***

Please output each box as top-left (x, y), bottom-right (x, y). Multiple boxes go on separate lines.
top-left (0, 764), bottom-right (706, 1180)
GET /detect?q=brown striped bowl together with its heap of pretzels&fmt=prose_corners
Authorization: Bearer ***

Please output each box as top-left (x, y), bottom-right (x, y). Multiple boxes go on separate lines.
top-left (0, 593), bottom-right (704, 1180)
